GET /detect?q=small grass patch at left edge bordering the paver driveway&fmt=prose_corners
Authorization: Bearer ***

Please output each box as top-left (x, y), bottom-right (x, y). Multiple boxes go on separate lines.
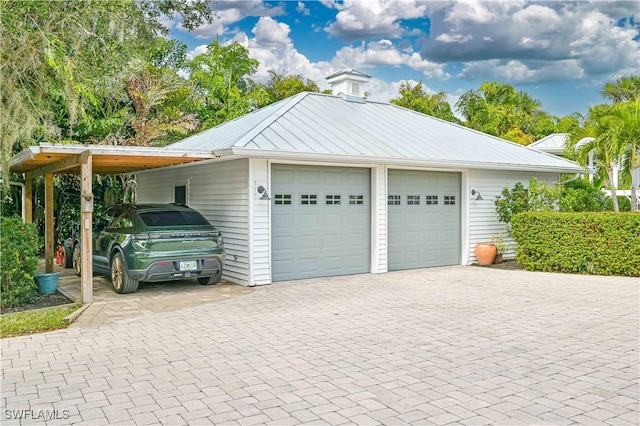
top-left (0, 303), bottom-right (82, 337)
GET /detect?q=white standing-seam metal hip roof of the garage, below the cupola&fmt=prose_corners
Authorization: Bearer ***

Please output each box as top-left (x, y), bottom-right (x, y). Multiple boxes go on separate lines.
top-left (168, 93), bottom-right (585, 173)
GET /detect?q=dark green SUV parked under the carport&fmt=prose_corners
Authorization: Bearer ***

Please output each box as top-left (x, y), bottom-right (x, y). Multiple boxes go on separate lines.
top-left (73, 204), bottom-right (224, 293)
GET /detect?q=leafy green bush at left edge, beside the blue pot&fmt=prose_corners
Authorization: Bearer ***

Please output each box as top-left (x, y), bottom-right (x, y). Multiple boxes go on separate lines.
top-left (0, 217), bottom-right (38, 307)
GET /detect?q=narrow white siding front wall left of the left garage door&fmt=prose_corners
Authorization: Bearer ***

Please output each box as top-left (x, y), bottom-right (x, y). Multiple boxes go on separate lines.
top-left (248, 158), bottom-right (273, 285)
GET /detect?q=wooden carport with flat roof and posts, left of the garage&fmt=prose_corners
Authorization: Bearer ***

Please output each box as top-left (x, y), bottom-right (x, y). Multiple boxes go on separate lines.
top-left (9, 143), bottom-right (216, 303)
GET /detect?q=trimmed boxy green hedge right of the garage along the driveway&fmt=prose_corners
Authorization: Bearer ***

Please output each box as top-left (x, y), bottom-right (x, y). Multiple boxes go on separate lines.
top-left (511, 212), bottom-right (640, 277)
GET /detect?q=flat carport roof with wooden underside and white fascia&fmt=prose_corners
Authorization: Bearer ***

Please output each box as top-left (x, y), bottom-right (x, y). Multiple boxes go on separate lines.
top-left (9, 143), bottom-right (215, 174)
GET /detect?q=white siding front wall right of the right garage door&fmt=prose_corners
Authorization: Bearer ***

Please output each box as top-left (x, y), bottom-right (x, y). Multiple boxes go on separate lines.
top-left (463, 170), bottom-right (558, 264)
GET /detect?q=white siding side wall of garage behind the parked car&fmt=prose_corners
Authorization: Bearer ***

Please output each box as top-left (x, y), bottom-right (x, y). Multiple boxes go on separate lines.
top-left (138, 159), bottom-right (251, 285)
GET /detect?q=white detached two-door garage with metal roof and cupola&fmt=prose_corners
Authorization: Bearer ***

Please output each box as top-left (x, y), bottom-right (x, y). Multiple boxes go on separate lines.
top-left (138, 70), bottom-right (584, 286)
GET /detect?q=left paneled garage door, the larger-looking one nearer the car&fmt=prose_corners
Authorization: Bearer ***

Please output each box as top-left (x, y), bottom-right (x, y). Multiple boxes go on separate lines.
top-left (271, 165), bottom-right (371, 281)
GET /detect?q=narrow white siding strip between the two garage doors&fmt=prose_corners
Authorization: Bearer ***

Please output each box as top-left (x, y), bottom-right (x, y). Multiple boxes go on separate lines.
top-left (371, 166), bottom-right (387, 274)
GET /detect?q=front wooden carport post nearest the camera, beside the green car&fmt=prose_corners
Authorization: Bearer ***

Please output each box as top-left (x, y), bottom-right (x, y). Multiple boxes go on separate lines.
top-left (80, 153), bottom-right (93, 303)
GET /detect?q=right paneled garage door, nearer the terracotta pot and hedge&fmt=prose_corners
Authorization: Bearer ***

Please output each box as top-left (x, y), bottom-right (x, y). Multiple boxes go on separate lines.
top-left (387, 170), bottom-right (461, 271)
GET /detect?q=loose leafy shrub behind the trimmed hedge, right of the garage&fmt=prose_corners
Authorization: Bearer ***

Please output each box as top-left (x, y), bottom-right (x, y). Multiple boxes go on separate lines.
top-left (494, 177), bottom-right (560, 229)
